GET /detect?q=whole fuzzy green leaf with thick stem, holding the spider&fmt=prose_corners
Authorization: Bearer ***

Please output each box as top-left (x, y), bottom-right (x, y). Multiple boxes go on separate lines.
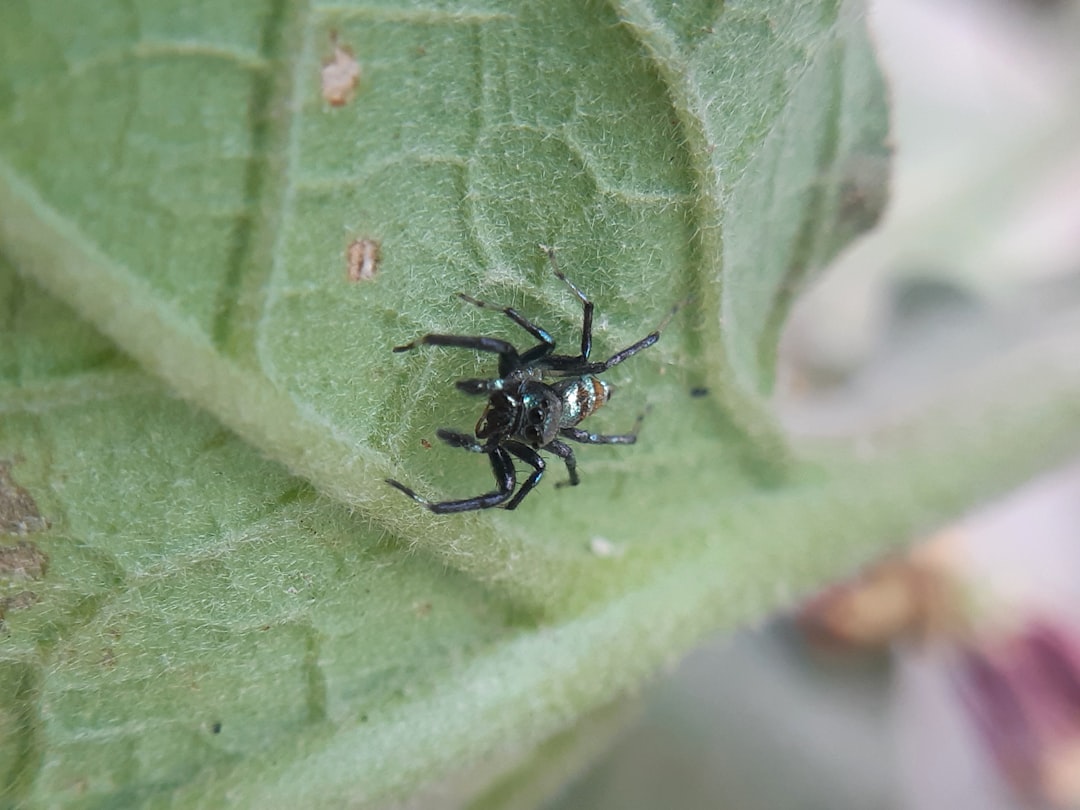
top-left (0, 0), bottom-right (1080, 807)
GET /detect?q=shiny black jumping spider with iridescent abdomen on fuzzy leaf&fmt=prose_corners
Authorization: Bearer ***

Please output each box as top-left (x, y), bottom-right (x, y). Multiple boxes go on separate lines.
top-left (387, 245), bottom-right (680, 514)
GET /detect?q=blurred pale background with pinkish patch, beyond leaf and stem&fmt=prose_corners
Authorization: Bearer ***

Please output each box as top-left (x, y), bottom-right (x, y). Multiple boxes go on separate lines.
top-left (545, 0), bottom-right (1080, 810)
